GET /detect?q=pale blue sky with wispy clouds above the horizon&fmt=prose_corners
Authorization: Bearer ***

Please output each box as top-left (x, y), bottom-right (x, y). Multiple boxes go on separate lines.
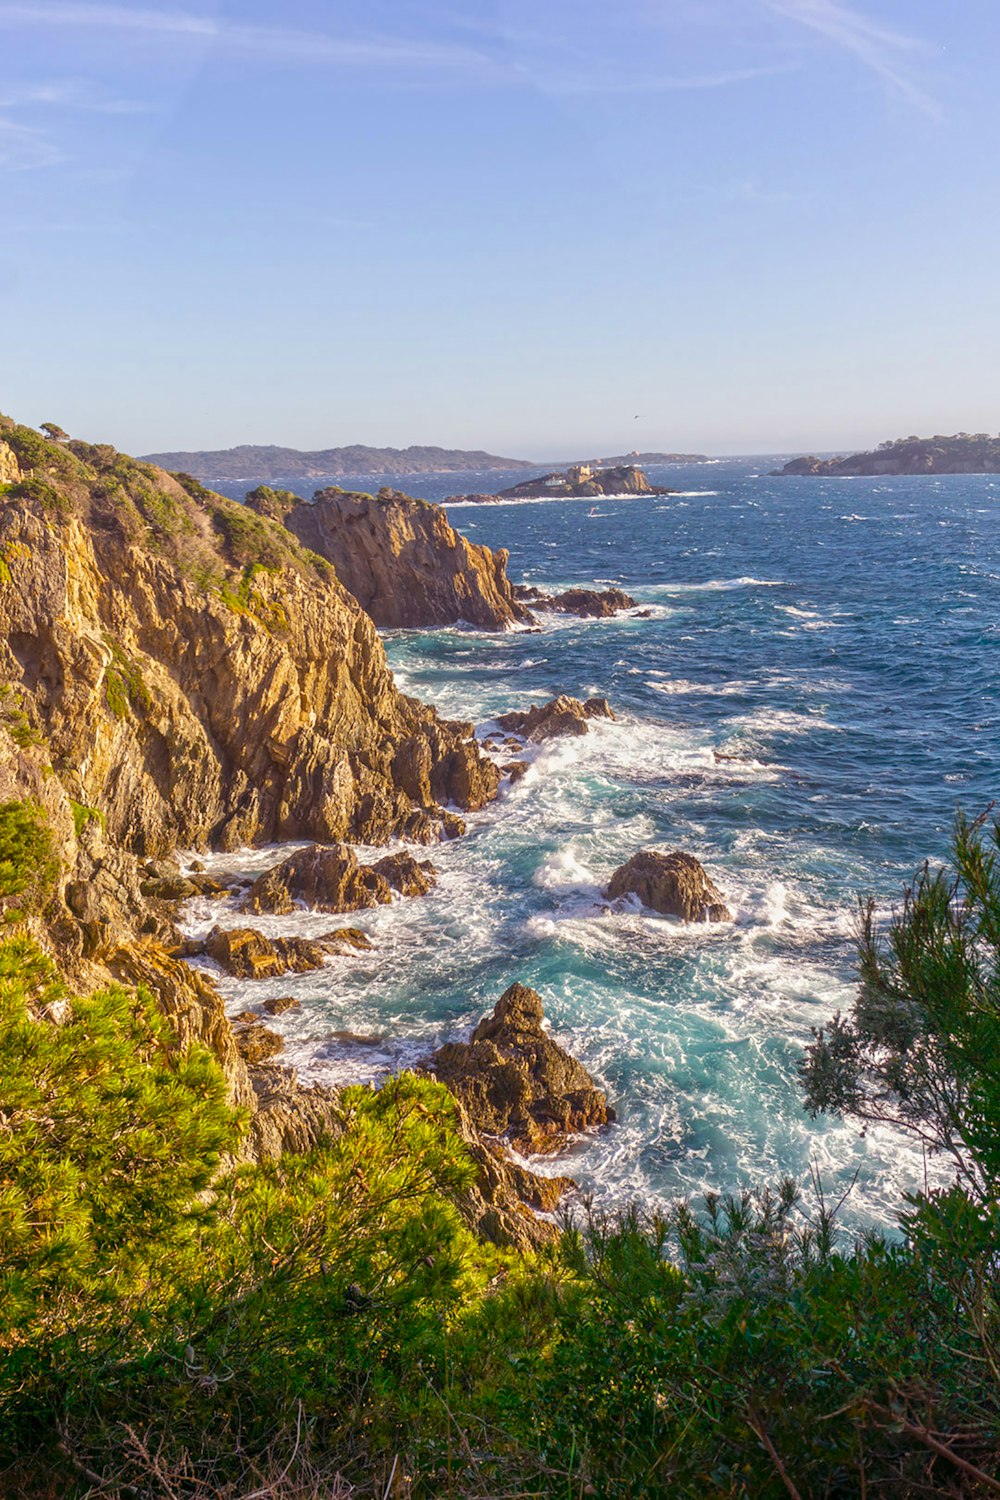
top-left (0, 0), bottom-right (1000, 459)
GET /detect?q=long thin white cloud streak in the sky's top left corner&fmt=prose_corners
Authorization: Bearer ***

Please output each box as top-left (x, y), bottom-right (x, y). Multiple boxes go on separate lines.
top-left (0, 0), bottom-right (489, 71)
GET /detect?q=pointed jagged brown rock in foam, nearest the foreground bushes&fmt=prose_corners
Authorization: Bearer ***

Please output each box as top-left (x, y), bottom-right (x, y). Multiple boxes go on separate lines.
top-left (430, 984), bottom-right (615, 1152)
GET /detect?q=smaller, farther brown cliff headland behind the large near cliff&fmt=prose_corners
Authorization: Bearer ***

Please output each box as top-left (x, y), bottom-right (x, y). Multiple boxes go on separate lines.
top-left (263, 489), bottom-right (531, 630)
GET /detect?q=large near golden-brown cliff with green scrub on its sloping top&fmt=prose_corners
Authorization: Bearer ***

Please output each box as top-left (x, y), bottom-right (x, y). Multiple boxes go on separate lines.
top-left (0, 444), bottom-right (498, 855)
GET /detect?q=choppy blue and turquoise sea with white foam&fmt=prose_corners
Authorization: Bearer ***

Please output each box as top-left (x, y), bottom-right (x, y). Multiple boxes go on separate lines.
top-left (195, 464), bottom-right (1000, 1218)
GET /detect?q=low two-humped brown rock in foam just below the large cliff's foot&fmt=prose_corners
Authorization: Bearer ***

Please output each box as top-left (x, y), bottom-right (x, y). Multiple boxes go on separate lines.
top-left (243, 845), bottom-right (436, 917)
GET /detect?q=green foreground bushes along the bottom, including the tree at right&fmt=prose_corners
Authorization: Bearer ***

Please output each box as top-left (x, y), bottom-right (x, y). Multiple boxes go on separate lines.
top-left (0, 825), bottom-right (1000, 1500)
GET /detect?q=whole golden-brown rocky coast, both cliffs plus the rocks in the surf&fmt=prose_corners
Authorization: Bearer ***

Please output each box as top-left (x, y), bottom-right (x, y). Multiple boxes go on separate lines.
top-left (0, 419), bottom-right (729, 1244)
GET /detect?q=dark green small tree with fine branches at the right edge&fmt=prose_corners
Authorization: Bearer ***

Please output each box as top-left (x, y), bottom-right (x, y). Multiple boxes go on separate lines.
top-left (802, 815), bottom-right (1000, 1203)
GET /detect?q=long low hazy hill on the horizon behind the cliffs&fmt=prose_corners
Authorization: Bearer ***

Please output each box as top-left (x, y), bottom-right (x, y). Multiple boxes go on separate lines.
top-left (138, 443), bottom-right (538, 485)
